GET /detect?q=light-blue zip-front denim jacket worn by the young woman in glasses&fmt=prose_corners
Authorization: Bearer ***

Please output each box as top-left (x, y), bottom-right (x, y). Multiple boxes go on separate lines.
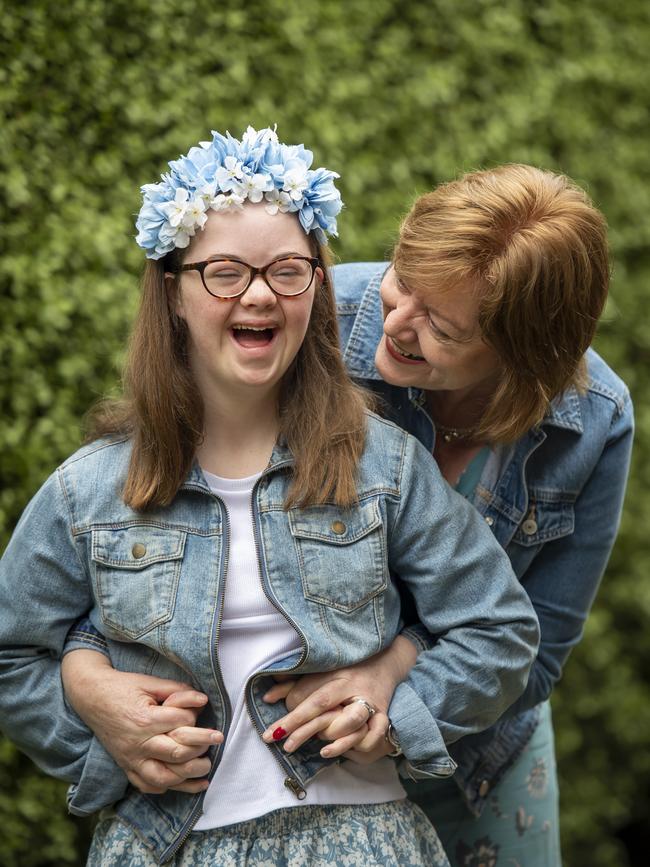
top-left (0, 414), bottom-right (538, 863)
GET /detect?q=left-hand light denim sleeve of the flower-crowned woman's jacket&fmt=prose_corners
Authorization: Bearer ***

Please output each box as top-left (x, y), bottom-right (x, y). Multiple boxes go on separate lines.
top-left (0, 471), bottom-right (126, 812)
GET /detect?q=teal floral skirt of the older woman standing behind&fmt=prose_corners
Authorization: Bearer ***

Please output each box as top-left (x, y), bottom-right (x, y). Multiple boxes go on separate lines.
top-left (407, 702), bottom-right (562, 867)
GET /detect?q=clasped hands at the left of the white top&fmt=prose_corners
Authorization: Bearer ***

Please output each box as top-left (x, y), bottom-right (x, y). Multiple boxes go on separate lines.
top-left (61, 650), bottom-right (223, 794)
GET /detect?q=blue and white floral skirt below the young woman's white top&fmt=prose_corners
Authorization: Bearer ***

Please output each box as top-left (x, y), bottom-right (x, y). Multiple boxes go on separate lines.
top-left (87, 800), bottom-right (449, 867)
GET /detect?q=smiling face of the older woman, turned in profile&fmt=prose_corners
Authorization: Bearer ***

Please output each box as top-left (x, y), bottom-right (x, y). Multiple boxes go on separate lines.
top-left (375, 266), bottom-right (500, 393)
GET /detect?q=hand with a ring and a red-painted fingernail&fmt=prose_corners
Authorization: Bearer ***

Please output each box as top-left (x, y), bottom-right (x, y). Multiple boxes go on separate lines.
top-left (262, 636), bottom-right (417, 760)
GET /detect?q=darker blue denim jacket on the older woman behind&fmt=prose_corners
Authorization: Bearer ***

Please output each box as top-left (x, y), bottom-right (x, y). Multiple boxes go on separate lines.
top-left (333, 262), bottom-right (634, 815)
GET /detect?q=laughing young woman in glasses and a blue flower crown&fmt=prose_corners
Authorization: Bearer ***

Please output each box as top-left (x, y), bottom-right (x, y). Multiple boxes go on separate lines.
top-left (0, 129), bottom-right (537, 867)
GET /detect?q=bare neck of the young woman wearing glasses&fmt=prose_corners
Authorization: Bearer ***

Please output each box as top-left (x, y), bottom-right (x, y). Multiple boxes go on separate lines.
top-left (197, 392), bottom-right (280, 479)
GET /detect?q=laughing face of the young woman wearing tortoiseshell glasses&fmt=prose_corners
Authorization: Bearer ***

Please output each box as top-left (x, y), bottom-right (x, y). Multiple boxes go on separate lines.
top-left (168, 203), bottom-right (322, 401)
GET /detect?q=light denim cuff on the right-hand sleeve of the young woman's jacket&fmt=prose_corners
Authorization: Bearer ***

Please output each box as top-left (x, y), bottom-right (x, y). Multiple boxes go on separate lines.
top-left (388, 683), bottom-right (456, 780)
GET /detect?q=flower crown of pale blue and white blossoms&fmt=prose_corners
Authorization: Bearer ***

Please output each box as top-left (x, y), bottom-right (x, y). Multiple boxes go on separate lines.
top-left (135, 126), bottom-right (343, 259)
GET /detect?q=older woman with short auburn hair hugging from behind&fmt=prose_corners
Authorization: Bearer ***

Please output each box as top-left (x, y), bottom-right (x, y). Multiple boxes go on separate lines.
top-left (58, 165), bottom-right (633, 867)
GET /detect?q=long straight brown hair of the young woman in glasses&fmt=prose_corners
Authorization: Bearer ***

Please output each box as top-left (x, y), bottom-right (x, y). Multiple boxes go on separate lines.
top-left (89, 236), bottom-right (368, 510)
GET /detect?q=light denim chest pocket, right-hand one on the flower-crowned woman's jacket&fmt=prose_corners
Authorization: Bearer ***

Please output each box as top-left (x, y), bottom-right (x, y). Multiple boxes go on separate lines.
top-left (289, 501), bottom-right (388, 612)
